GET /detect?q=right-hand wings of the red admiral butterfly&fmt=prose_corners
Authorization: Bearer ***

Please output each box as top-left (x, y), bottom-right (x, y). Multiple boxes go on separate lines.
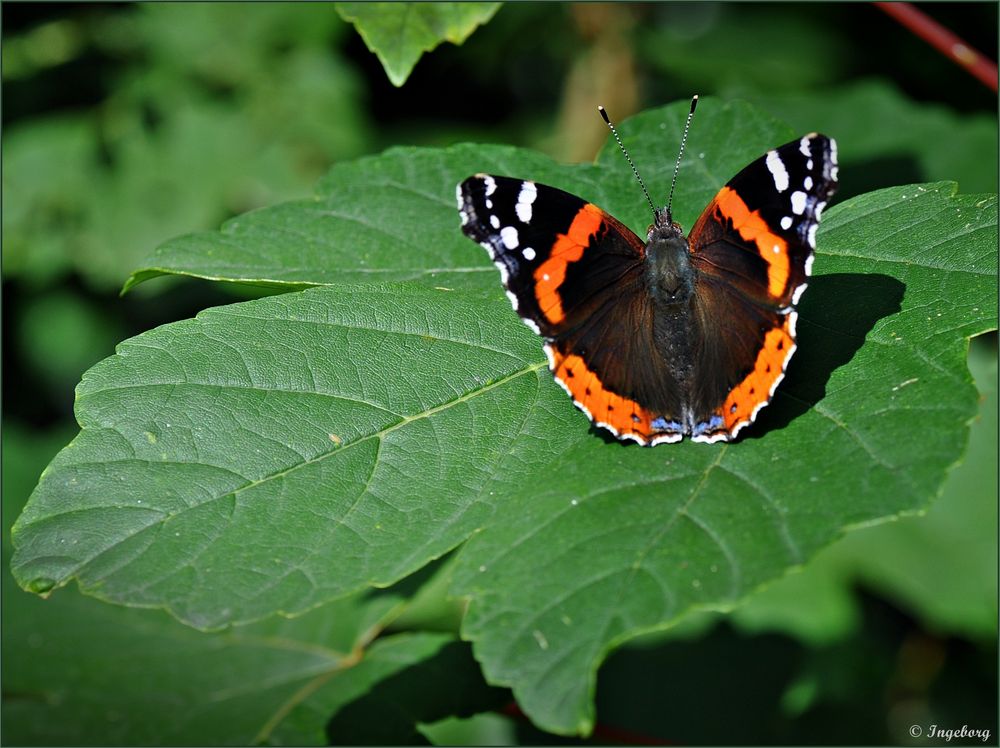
top-left (688, 133), bottom-right (837, 441)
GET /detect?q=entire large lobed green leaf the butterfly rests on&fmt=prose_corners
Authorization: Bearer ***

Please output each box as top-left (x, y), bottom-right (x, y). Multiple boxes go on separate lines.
top-left (14, 96), bottom-right (997, 732)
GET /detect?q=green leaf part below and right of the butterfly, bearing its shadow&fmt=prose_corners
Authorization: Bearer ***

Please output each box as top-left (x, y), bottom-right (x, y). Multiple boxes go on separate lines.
top-left (456, 185), bottom-right (996, 731)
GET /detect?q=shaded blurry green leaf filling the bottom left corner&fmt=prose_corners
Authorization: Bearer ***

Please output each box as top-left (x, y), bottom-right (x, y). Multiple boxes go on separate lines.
top-left (3, 582), bottom-right (406, 745)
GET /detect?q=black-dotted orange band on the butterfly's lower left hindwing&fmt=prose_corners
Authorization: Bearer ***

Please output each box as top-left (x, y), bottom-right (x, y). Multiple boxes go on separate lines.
top-left (549, 346), bottom-right (662, 444)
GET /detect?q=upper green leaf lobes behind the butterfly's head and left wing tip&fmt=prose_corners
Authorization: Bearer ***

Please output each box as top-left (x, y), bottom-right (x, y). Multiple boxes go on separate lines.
top-left (125, 100), bottom-right (795, 290)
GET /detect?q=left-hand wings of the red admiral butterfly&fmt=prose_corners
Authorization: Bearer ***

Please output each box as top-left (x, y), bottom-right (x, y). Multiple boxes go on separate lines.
top-left (457, 174), bottom-right (681, 444)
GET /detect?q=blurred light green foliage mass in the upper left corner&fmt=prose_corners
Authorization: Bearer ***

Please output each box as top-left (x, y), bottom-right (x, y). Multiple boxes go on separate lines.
top-left (3, 3), bottom-right (370, 288)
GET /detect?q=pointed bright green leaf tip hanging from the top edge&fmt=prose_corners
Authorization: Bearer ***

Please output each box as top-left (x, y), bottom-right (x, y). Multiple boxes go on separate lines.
top-left (337, 2), bottom-right (500, 86)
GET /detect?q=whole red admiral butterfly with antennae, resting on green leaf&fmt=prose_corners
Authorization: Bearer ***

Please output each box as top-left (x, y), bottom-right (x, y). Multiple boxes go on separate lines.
top-left (457, 97), bottom-right (837, 445)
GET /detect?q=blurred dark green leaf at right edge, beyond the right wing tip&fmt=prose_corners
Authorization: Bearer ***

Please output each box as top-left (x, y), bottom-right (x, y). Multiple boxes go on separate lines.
top-left (754, 80), bottom-right (997, 195)
